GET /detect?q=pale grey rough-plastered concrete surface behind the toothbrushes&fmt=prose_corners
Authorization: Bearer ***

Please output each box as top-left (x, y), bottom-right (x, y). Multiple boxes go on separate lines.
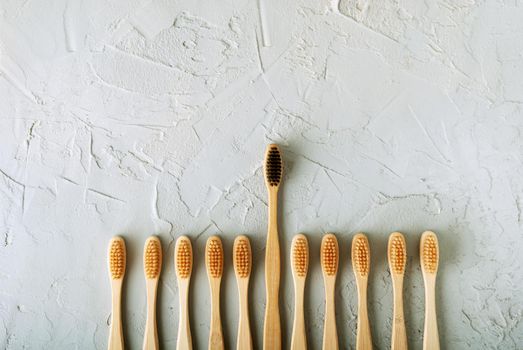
top-left (0, 0), bottom-right (523, 349)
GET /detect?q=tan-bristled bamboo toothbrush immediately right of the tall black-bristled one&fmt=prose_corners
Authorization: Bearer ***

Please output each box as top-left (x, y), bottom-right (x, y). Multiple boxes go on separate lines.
top-left (291, 234), bottom-right (309, 350)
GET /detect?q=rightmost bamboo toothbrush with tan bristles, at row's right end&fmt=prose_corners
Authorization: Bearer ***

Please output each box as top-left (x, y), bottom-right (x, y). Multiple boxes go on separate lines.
top-left (420, 231), bottom-right (439, 350)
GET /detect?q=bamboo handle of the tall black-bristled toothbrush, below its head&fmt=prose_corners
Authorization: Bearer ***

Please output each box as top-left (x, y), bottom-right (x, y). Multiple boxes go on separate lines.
top-left (263, 188), bottom-right (281, 350)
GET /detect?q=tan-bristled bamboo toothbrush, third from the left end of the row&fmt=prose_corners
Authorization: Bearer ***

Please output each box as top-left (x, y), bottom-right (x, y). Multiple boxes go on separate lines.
top-left (174, 236), bottom-right (193, 350)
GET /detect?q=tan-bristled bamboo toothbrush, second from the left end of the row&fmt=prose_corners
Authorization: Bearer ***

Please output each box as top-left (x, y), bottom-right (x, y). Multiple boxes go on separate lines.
top-left (143, 236), bottom-right (162, 350)
